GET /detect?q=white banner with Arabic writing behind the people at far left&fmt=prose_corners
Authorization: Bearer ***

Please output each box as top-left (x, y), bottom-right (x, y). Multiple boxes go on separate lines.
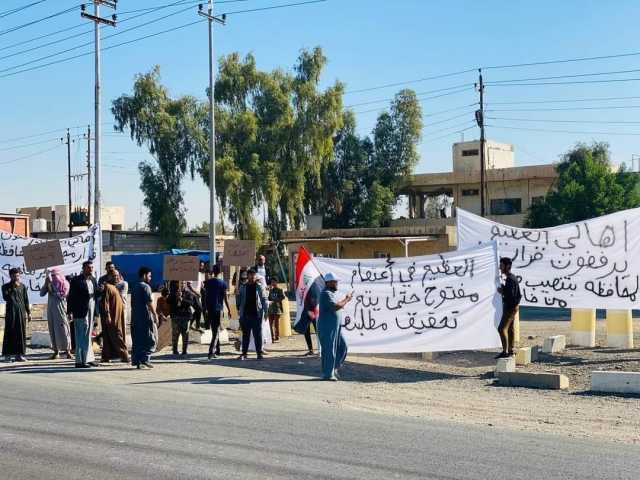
top-left (0, 225), bottom-right (102, 305)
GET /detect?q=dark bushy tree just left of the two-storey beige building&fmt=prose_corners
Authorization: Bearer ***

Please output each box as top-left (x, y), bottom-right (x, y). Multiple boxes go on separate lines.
top-left (323, 90), bottom-right (422, 228)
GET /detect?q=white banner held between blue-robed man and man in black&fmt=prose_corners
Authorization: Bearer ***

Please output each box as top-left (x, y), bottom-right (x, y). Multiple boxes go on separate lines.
top-left (313, 242), bottom-right (502, 353)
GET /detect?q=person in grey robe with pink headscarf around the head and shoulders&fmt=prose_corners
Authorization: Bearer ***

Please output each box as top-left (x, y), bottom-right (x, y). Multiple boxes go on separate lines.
top-left (40, 268), bottom-right (73, 360)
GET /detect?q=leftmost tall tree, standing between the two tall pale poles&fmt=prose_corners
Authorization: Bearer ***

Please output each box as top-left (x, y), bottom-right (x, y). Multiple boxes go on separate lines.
top-left (111, 66), bottom-right (206, 247)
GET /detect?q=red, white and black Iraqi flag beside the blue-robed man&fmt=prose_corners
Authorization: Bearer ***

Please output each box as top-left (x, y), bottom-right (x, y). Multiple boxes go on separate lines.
top-left (293, 247), bottom-right (324, 334)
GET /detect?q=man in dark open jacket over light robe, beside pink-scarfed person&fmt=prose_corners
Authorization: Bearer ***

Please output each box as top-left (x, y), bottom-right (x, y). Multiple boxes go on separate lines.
top-left (67, 261), bottom-right (99, 368)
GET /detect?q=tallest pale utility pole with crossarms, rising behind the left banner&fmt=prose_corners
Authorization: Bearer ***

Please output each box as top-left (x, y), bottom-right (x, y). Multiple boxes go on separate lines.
top-left (80, 0), bottom-right (118, 235)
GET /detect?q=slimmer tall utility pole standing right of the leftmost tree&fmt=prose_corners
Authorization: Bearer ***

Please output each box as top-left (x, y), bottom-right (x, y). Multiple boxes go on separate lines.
top-left (198, 0), bottom-right (226, 268)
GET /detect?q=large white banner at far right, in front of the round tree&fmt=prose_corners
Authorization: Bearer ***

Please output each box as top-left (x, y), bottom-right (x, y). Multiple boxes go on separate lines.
top-left (457, 208), bottom-right (640, 309)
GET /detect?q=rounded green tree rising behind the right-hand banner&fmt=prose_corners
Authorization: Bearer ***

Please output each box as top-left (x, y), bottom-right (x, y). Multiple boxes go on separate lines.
top-left (525, 143), bottom-right (640, 228)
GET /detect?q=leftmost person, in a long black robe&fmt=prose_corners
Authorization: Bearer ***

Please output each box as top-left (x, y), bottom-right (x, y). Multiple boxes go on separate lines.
top-left (2, 268), bottom-right (31, 362)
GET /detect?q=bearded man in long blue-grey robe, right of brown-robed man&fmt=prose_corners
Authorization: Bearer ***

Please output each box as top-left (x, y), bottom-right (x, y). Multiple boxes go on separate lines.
top-left (131, 267), bottom-right (158, 370)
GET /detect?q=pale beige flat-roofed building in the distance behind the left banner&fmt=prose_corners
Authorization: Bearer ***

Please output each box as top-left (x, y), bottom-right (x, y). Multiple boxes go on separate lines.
top-left (18, 205), bottom-right (125, 232)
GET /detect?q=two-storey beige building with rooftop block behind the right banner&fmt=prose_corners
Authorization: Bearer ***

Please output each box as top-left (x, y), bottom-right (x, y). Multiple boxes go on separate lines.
top-left (400, 140), bottom-right (557, 227)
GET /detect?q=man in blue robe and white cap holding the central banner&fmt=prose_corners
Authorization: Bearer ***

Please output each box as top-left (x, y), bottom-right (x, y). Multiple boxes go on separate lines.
top-left (318, 273), bottom-right (353, 382)
